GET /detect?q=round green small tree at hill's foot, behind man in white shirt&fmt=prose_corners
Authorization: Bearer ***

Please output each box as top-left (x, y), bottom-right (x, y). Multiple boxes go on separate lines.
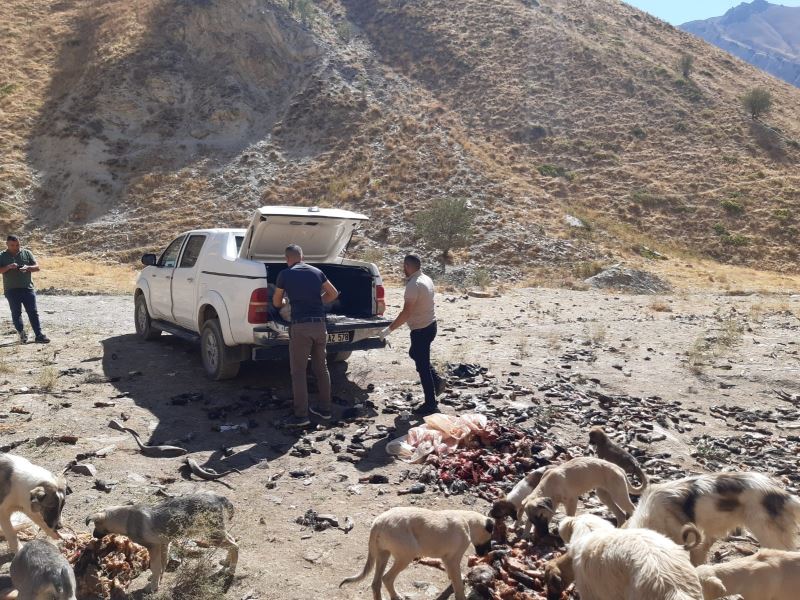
top-left (416, 198), bottom-right (474, 267)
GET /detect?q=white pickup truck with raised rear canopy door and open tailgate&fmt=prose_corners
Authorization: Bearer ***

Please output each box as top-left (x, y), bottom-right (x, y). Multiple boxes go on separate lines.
top-left (134, 206), bottom-right (390, 380)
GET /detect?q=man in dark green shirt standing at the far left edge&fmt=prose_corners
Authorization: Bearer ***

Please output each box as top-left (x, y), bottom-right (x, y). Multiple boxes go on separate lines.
top-left (0, 235), bottom-right (50, 344)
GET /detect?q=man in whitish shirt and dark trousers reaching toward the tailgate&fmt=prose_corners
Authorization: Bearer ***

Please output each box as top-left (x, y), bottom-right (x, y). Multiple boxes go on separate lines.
top-left (381, 254), bottom-right (443, 415)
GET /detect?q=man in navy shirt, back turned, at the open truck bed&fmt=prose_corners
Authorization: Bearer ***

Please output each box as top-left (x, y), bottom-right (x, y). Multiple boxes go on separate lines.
top-left (272, 244), bottom-right (339, 428)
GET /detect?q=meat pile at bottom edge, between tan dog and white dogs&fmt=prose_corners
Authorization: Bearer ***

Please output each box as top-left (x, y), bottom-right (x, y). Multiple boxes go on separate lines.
top-left (467, 540), bottom-right (574, 600)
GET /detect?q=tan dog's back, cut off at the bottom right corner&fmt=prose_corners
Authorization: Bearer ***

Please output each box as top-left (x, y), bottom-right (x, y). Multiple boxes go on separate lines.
top-left (697, 549), bottom-right (800, 600)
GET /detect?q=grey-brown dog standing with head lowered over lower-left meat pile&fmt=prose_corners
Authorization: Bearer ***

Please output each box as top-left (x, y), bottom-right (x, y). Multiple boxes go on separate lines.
top-left (86, 492), bottom-right (239, 592)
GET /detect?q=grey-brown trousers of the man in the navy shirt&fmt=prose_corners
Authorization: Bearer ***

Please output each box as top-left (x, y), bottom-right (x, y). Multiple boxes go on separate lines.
top-left (289, 322), bottom-right (331, 417)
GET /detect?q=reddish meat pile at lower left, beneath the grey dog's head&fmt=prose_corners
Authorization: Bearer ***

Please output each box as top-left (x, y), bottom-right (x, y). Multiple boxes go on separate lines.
top-left (63, 533), bottom-right (150, 600)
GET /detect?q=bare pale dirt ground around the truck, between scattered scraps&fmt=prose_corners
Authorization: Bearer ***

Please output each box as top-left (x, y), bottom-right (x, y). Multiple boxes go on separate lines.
top-left (0, 289), bottom-right (800, 600)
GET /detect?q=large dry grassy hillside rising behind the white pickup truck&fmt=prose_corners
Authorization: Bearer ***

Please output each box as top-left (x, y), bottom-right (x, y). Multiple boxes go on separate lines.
top-left (0, 0), bottom-right (800, 277)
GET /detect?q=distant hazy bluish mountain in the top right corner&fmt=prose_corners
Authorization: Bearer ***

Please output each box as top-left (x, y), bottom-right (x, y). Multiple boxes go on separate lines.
top-left (681, 0), bottom-right (800, 87)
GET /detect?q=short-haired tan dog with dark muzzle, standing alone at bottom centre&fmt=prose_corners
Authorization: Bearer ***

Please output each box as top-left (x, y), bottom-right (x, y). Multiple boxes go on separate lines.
top-left (339, 507), bottom-right (494, 600)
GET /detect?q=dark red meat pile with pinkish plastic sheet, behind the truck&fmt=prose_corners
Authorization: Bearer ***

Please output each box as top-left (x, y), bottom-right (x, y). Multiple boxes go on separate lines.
top-left (386, 414), bottom-right (563, 501)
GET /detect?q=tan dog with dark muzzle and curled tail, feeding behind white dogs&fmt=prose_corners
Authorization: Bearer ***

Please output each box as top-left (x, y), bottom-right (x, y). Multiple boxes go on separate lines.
top-left (517, 456), bottom-right (642, 538)
